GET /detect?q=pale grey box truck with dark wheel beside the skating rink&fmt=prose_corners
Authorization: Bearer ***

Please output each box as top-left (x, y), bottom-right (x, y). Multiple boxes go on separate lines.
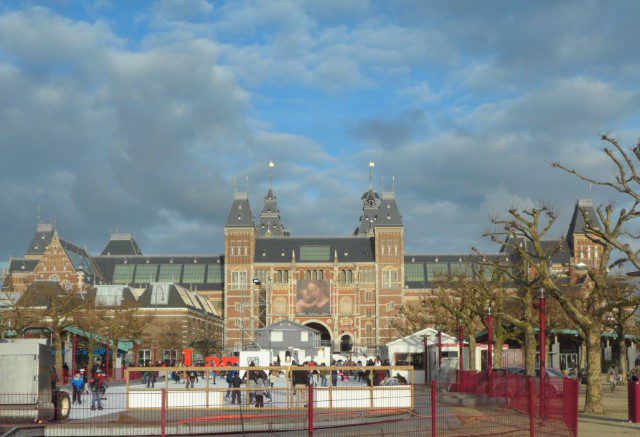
top-left (0, 338), bottom-right (71, 423)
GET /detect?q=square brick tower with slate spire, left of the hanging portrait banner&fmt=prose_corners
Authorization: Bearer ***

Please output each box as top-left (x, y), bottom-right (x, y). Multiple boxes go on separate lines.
top-left (224, 179), bottom-right (258, 347)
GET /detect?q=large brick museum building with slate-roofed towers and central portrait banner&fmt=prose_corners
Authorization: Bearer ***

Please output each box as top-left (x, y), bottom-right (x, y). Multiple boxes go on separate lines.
top-left (3, 172), bottom-right (599, 350)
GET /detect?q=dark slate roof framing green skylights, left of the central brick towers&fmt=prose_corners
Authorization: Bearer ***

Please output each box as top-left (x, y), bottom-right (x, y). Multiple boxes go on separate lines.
top-left (94, 255), bottom-right (224, 290)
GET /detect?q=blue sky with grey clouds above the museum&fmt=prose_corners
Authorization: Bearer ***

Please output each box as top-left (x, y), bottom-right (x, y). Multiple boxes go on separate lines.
top-left (0, 0), bottom-right (640, 264)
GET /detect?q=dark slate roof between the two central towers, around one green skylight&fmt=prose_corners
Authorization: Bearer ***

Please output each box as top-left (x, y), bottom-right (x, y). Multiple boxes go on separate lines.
top-left (254, 236), bottom-right (375, 263)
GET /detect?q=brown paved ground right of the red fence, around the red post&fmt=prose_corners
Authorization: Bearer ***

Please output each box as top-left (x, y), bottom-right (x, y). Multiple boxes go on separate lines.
top-left (578, 378), bottom-right (640, 437)
